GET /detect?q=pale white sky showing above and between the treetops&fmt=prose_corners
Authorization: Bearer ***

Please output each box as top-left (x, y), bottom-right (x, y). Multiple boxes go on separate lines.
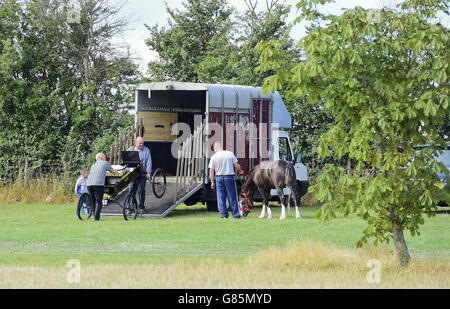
top-left (114, 0), bottom-right (444, 72)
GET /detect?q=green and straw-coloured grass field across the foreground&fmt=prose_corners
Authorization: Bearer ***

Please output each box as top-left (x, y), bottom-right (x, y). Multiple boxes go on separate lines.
top-left (0, 205), bottom-right (450, 288)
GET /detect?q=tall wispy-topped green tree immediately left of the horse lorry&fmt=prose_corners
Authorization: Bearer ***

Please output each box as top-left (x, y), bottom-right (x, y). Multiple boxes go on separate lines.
top-left (29, 0), bottom-right (140, 155)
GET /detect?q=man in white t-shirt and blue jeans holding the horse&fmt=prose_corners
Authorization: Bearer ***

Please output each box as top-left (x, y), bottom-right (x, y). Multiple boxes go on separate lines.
top-left (208, 142), bottom-right (244, 219)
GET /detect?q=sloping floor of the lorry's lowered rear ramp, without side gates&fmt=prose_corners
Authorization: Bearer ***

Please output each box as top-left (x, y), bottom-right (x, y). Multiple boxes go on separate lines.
top-left (101, 177), bottom-right (203, 218)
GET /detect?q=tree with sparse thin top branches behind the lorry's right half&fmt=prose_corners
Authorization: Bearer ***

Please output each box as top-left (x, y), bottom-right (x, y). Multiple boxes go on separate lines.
top-left (197, 0), bottom-right (300, 86)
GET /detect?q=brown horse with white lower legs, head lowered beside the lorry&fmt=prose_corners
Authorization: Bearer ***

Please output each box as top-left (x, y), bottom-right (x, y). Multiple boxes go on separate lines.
top-left (240, 160), bottom-right (300, 220)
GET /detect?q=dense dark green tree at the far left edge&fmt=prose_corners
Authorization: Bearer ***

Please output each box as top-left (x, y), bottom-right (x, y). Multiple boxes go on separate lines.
top-left (0, 0), bottom-right (64, 172)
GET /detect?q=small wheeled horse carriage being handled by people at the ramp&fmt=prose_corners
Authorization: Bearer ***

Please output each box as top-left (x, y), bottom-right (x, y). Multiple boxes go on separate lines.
top-left (77, 151), bottom-right (166, 220)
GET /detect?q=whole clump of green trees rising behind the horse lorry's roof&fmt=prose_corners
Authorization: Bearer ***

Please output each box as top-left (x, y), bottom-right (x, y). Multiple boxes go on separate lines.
top-left (147, 0), bottom-right (300, 86)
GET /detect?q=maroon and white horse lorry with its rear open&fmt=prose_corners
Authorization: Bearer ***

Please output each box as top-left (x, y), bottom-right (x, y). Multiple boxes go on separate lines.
top-left (130, 82), bottom-right (308, 214)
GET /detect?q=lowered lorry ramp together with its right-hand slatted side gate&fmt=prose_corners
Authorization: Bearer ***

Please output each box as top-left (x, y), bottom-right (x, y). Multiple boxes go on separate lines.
top-left (101, 123), bottom-right (206, 218)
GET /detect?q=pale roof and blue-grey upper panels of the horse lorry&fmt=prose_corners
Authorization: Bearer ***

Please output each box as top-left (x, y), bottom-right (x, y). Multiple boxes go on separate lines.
top-left (137, 81), bottom-right (292, 128)
